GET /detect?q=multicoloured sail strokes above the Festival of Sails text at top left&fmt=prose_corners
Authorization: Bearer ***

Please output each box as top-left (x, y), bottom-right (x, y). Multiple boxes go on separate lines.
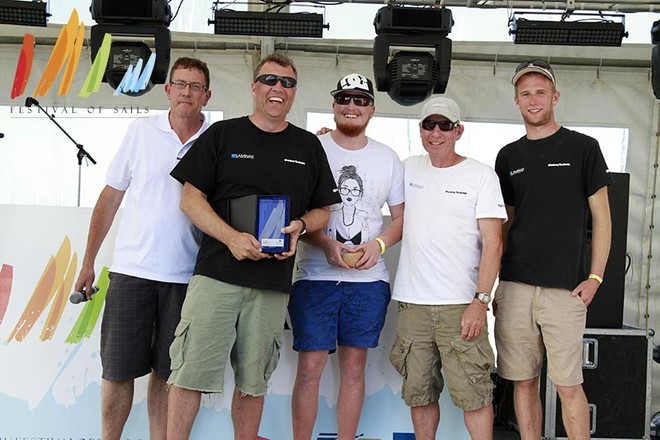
top-left (11, 9), bottom-right (156, 99)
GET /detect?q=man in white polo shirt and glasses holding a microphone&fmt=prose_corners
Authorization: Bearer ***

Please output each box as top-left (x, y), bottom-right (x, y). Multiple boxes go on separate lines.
top-left (75, 57), bottom-right (211, 440)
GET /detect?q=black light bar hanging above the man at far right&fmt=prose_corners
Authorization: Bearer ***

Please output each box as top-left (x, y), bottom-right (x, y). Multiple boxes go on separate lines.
top-left (509, 12), bottom-right (628, 46)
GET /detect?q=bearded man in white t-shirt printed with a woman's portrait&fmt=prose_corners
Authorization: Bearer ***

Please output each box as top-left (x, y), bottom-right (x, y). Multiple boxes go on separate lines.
top-left (289, 73), bottom-right (404, 440)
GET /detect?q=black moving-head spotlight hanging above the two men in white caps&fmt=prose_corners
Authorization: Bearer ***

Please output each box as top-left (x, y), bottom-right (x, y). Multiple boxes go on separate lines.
top-left (373, 6), bottom-right (454, 106)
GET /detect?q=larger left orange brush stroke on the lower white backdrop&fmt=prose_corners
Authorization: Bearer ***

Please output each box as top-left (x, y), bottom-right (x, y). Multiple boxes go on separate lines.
top-left (7, 236), bottom-right (71, 342)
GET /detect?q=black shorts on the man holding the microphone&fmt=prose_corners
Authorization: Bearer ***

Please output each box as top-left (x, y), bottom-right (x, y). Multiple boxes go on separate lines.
top-left (101, 273), bottom-right (188, 381)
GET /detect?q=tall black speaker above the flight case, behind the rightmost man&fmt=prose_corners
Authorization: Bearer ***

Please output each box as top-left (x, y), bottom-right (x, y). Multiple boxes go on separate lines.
top-left (586, 173), bottom-right (630, 328)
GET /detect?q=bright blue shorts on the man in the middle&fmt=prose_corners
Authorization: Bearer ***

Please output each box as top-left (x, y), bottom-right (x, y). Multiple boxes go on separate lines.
top-left (289, 280), bottom-right (390, 351)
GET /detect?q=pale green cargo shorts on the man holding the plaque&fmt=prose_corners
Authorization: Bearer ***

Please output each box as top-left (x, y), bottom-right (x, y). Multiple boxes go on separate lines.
top-left (168, 275), bottom-right (289, 396)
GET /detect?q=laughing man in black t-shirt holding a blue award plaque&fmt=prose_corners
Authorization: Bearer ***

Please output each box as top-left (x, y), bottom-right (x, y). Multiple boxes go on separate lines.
top-left (168, 53), bottom-right (340, 439)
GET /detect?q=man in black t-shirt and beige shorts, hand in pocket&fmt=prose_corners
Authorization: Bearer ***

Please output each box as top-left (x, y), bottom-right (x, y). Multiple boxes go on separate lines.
top-left (495, 60), bottom-right (612, 440)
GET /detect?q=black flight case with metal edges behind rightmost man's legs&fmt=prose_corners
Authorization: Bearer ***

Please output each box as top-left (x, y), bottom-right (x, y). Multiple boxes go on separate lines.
top-left (541, 329), bottom-right (653, 440)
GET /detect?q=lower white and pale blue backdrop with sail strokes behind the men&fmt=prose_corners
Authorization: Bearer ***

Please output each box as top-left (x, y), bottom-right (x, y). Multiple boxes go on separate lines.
top-left (0, 205), bottom-right (469, 440)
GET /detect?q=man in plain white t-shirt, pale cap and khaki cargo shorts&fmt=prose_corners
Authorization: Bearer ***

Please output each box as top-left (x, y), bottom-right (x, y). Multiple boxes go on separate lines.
top-left (390, 97), bottom-right (506, 440)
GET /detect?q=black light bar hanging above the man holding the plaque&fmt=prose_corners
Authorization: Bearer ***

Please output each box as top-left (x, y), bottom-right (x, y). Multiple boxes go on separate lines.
top-left (209, 9), bottom-right (329, 38)
